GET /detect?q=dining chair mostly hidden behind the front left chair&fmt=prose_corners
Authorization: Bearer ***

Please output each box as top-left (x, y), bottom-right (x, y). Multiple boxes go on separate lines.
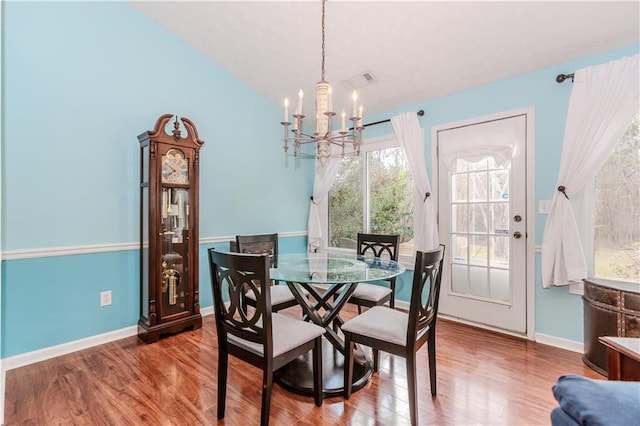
top-left (235, 233), bottom-right (298, 312)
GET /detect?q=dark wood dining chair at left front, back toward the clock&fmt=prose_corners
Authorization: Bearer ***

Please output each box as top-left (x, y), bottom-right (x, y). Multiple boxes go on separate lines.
top-left (209, 248), bottom-right (325, 425)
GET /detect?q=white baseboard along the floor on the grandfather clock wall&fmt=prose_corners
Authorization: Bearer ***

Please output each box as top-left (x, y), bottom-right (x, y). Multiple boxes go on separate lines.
top-left (0, 306), bottom-right (213, 372)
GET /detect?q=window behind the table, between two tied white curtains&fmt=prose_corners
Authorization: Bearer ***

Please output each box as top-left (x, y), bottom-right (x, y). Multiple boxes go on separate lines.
top-left (326, 136), bottom-right (413, 256)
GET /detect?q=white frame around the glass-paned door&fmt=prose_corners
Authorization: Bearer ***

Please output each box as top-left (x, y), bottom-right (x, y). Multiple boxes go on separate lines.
top-left (431, 106), bottom-right (536, 340)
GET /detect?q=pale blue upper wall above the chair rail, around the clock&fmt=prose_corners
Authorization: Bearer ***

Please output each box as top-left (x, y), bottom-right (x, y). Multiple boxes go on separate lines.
top-left (2, 2), bottom-right (313, 250)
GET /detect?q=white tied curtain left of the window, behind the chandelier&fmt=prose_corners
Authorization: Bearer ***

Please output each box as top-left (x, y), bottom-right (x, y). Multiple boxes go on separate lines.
top-left (307, 145), bottom-right (342, 252)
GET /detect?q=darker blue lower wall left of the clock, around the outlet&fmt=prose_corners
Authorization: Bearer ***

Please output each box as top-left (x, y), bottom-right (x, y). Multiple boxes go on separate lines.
top-left (2, 250), bottom-right (140, 358)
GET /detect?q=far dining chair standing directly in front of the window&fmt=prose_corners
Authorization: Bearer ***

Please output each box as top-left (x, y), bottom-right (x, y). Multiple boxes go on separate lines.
top-left (347, 233), bottom-right (400, 314)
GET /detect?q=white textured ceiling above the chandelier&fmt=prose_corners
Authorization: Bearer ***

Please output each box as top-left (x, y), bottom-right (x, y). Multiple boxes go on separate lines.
top-left (131, 0), bottom-right (640, 115)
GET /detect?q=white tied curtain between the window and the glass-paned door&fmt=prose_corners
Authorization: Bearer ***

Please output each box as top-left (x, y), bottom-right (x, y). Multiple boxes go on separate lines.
top-left (391, 112), bottom-right (440, 251)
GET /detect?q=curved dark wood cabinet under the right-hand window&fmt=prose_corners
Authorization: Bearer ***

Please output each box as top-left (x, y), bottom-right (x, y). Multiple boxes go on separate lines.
top-left (582, 279), bottom-right (640, 375)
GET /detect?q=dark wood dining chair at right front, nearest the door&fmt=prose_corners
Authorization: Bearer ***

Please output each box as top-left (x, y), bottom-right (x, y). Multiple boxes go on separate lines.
top-left (342, 245), bottom-right (444, 425)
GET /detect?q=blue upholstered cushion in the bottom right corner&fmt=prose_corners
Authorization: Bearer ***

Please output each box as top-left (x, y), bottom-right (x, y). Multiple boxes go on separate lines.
top-left (552, 375), bottom-right (640, 425)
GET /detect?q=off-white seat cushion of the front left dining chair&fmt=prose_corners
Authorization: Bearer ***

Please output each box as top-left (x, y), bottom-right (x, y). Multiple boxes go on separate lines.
top-left (228, 313), bottom-right (325, 357)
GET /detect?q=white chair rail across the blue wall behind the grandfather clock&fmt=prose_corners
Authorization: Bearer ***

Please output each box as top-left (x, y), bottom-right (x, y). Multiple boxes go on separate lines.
top-left (2, 231), bottom-right (307, 260)
